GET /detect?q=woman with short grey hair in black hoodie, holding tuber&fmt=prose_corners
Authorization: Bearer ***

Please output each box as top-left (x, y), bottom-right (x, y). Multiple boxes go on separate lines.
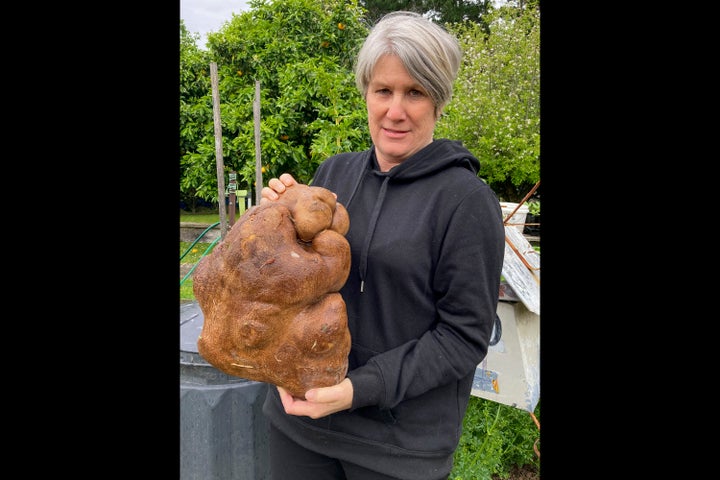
top-left (262, 12), bottom-right (504, 480)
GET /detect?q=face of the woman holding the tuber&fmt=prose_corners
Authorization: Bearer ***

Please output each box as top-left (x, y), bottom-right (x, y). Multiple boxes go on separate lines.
top-left (365, 55), bottom-right (437, 172)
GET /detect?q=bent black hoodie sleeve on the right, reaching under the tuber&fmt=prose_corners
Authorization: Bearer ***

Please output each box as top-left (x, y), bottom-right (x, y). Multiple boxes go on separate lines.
top-left (348, 184), bottom-right (505, 410)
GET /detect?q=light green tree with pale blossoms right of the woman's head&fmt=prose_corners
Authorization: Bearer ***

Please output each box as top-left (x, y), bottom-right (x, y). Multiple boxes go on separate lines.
top-left (436, 7), bottom-right (540, 202)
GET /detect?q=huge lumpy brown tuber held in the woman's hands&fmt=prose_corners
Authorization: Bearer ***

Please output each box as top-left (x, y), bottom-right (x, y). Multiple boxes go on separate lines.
top-left (193, 184), bottom-right (350, 398)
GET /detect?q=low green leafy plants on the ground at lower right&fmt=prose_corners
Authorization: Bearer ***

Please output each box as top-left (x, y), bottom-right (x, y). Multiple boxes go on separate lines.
top-left (449, 397), bottom-right (540, 480)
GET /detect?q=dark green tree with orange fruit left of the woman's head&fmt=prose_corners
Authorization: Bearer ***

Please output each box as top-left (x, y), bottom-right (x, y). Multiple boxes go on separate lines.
top-left (181, 0), bottom-right (369, 204)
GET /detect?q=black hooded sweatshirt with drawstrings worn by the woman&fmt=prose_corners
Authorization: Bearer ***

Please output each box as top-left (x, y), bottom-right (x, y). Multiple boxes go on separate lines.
top-left (263, 139), bottom-right (505, 480)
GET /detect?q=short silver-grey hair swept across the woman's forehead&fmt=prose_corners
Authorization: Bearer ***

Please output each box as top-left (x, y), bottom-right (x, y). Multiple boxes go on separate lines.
top-left (355, 11), bottom-right (462, 113)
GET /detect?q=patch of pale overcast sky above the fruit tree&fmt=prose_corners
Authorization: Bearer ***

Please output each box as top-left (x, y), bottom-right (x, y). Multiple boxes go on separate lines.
top-left (180, 0), bottom-right (250, 49)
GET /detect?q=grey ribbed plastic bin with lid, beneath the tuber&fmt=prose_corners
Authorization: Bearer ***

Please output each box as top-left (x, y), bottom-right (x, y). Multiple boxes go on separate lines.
top-left (180, 302), bottom-right (270, 480)
